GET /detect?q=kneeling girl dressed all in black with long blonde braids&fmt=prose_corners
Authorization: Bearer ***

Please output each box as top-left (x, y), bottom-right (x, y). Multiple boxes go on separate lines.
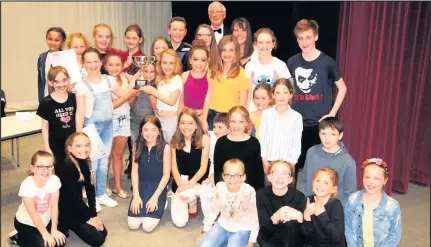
top-left (56, 132), bottom-right (108, 247)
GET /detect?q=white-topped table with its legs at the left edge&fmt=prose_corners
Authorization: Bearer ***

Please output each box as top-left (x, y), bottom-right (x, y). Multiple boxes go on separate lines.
top-left (1, 112), bottom-right (42, 167)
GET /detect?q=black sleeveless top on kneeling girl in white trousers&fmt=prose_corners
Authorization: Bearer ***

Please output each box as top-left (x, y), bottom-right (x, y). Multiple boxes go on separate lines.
top-left (172, 145), bottom-right (210, 192)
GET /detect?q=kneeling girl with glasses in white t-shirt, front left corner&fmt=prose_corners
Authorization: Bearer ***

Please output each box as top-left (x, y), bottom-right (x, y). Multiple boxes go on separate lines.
top-left (11, 150), bottom-right (66, 247)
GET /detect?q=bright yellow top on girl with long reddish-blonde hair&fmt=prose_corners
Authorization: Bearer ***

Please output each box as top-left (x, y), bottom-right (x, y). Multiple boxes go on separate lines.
top-left (208, 68), bottom-right (251, 112)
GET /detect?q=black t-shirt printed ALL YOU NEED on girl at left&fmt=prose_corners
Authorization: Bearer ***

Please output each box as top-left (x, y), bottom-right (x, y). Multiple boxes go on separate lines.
top-left (36, 93), bottom-right (76, 140)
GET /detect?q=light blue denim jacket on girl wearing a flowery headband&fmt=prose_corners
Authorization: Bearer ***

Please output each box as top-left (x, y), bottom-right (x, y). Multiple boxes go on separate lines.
top-left (344, 189), bottom-right (402, 247)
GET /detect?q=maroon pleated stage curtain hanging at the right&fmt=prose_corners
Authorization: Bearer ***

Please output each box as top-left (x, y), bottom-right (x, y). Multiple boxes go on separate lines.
top-left (337, 2), bottom-right (431, 193)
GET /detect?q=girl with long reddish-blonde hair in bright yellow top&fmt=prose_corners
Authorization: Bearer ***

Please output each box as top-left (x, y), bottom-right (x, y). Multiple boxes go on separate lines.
top-left (208, 35), bottom-right (251, 131)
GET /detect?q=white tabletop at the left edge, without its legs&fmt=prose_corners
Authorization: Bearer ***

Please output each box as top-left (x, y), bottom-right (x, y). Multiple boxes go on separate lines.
top-left (1, 112), bottom-right (42, 141)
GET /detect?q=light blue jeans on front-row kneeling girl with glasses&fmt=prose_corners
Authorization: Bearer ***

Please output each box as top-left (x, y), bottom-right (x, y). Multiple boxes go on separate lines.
top-left (198, 222), bottom-right (251, 247)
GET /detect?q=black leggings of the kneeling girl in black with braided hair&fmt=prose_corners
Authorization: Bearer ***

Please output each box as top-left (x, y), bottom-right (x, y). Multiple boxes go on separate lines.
top-left (61, 223), bottom-right (108, 247)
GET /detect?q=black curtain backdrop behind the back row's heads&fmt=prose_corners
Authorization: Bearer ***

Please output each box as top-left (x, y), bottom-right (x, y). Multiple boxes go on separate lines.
top-left (172, 1), bottom-right (340, 62)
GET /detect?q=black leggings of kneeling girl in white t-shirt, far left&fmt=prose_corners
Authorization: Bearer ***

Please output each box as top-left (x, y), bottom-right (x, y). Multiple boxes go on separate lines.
top-left (14, 217), bottom-right (64, 247)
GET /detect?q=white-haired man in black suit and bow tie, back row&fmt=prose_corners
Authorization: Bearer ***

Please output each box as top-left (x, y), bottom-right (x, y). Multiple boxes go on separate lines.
top-left (208, 1), bottom-right (230, 44)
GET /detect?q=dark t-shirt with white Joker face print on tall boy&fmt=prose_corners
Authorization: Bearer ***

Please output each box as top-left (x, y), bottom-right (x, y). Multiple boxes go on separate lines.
top-left (287, 52), bottom-right (341, 127)
